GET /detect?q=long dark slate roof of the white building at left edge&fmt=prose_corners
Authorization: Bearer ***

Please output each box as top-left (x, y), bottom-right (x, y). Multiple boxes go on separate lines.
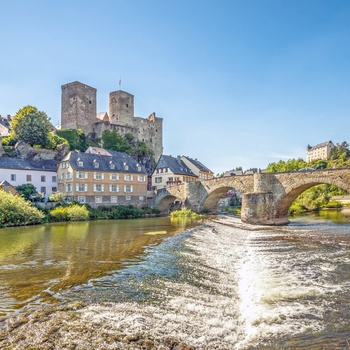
top-left (0, 157), bottom-right (59, 172)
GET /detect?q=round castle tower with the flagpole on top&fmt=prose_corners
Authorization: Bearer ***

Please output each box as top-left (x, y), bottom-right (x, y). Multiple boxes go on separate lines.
top-left (109, 90), bottom-right (134, 127)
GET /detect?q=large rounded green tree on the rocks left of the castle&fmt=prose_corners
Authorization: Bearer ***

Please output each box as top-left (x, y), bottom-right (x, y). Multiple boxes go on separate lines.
top-left (11, 106), bottom-right (52, 147)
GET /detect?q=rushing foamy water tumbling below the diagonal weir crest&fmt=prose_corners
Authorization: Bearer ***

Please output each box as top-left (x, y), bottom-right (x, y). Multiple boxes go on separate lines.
top-left (2, 217), bottom-right (350, 350)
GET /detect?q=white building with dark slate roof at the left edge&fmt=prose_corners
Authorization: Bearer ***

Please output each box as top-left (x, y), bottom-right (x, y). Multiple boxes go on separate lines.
top-left (0, 157), bottom-right (58, 200)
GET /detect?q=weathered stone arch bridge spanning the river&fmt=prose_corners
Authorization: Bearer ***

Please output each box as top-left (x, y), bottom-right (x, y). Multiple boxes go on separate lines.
top-left (152, 169), bottom-right (350, 225)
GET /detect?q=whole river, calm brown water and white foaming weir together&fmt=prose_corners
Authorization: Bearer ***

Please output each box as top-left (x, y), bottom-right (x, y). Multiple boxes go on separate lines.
top-left (0, 212), bottom-right (350, 349)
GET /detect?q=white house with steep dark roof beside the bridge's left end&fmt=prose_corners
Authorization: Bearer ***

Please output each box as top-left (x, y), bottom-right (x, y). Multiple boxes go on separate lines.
top-left (152, 154), bottom-right (199, 190)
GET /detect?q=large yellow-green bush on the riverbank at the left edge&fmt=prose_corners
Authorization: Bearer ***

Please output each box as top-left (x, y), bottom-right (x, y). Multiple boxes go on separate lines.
top-left (0, 190), bottom-right (44, 227)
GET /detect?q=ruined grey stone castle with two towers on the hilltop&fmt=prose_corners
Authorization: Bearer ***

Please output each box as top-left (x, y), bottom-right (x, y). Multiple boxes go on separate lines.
top-left (61, 81), bottom-right (163, 161)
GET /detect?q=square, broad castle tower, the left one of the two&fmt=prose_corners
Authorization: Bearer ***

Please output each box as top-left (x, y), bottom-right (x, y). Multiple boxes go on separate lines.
top-left (61, 81), bottom-right (97, 136)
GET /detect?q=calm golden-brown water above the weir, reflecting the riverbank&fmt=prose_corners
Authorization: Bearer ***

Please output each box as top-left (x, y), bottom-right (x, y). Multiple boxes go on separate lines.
top-left (0, 218), bottom-right (198, 315)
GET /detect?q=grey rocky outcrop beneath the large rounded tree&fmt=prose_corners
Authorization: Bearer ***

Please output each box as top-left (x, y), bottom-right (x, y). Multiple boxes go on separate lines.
top-left (15, 141), bottom-right (69, 161)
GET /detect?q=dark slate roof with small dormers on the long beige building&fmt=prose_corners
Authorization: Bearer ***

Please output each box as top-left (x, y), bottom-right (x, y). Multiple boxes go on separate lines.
top-left (62, 151), bottom-right (147, 174)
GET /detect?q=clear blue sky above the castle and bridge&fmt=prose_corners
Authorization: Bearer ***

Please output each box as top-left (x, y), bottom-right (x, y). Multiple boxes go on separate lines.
top-left (0, 0), bottom-right (350, 174)
